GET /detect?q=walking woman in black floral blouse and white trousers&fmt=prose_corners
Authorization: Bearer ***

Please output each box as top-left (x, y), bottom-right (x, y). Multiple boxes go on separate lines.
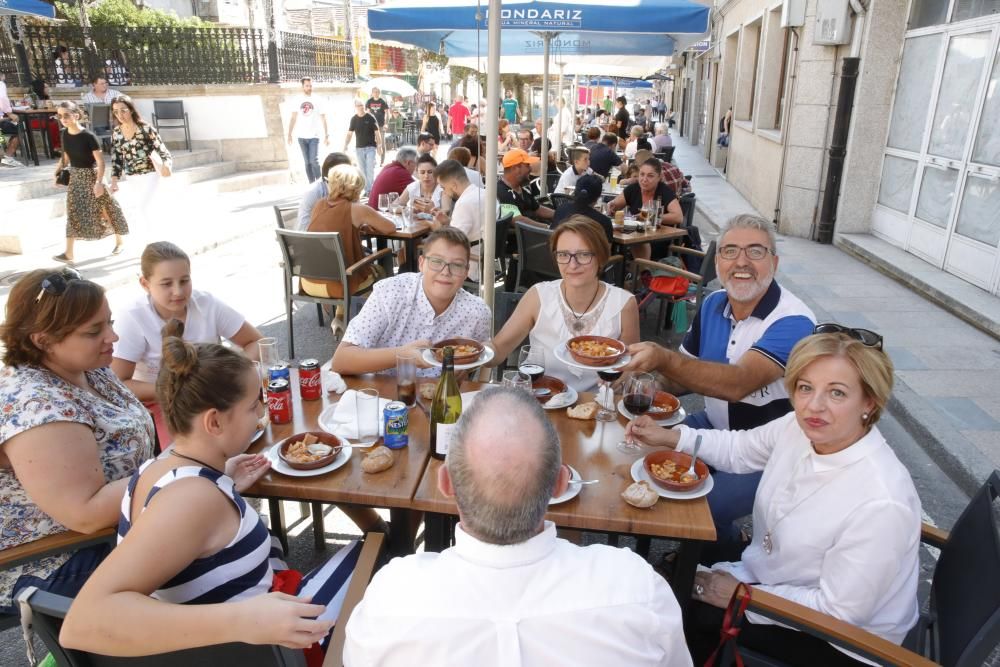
top-left (111, 95), bottom-right (173, 243)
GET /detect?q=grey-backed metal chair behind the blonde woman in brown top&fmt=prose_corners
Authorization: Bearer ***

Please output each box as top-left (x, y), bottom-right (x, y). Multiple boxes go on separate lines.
top-left (275, 229), bottom-right (392, 358)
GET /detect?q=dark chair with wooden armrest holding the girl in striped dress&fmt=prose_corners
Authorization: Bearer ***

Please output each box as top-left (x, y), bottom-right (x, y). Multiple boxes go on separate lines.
top-left (20, 533), bottom-right (385, 667)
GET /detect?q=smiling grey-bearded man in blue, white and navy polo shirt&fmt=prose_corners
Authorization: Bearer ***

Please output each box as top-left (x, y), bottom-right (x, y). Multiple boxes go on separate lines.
top-left (625, 215), bottom-right (816, 559)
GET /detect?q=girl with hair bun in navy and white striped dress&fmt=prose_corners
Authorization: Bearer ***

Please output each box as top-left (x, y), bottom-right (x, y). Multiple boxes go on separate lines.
top-left (61, 320), bottom-right (360, 663)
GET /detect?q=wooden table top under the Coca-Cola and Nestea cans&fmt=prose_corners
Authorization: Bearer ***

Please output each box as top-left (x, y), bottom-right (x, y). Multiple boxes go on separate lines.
top-left (244, 368), bottom-right (430, 508)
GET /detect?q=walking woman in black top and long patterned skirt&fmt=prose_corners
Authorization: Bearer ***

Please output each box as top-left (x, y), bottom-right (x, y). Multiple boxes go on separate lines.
top-left (53, 102), bottom-right (128, 263)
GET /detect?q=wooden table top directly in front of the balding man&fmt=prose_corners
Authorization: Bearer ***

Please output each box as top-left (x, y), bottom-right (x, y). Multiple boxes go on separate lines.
top-left (410, 383), bottom-right (716, 541)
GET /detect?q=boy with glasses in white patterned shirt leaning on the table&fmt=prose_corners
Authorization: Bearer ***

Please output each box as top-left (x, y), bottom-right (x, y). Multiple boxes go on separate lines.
top-left (332, 227), bottom-right (492, 377)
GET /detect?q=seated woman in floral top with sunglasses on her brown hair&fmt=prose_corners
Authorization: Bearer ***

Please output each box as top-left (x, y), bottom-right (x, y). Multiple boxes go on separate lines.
top-left (0, 267), bottom-right (154, 613)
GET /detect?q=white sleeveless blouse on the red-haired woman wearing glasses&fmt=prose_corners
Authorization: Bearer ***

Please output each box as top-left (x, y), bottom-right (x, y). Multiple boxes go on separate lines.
top-left (529, 279), bottom-right (635, 391)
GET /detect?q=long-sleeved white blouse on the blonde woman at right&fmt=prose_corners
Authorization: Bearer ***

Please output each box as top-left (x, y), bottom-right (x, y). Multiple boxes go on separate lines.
top-left (677, 413), bottom-right (921, 656)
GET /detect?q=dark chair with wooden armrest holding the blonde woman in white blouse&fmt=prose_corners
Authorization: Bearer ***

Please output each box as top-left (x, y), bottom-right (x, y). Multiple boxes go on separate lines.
top-left (723, 470), bottom-right (1000, 667)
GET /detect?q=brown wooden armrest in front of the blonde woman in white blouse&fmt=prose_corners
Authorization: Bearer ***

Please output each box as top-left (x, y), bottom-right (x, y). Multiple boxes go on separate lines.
top-left (747, 588), bottom-right (936, 667)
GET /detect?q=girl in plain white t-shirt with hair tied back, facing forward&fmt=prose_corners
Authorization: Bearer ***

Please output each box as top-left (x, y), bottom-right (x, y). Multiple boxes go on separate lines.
top-left (111, 241), bottom-right (262, 447)
